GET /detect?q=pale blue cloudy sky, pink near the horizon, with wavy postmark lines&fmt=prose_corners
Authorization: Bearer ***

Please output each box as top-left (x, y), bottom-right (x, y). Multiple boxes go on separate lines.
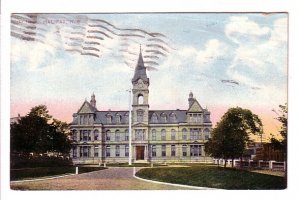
top-left (10, 13), bottom-right (288, 139)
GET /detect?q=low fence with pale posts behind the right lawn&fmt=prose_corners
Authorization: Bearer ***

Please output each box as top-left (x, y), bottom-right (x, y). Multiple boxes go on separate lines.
top-left (213, 159), bottom-right (286, 171)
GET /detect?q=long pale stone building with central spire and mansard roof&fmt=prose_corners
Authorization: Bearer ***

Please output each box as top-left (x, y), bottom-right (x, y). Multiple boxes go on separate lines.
top-left (71, 50), bottom-right (212, 164)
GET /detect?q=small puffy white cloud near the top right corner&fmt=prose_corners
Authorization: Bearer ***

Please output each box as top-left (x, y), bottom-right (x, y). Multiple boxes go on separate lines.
top-left (225, 16), bottom-right (270, 44)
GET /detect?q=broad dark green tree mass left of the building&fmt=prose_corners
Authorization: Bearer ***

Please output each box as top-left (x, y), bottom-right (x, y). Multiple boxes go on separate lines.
top-left (11, 105), bottom-right (71, 154)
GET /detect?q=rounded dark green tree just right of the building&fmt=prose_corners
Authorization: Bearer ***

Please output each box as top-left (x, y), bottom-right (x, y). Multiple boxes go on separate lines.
top-left (205, 107), bottom-right (262, 167)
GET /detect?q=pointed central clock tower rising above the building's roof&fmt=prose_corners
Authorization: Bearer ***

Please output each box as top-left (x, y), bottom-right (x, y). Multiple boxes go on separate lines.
top-left (131, 47), bottom-right (149, 125)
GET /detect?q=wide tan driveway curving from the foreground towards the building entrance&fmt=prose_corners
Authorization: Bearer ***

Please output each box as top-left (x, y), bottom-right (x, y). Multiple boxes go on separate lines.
top-left (11, 168), bottom-right (205, 190)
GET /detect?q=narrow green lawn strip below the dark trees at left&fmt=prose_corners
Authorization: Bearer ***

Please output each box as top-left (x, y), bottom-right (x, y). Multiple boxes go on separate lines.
top-left (10, 166), bottom-right (106, 181)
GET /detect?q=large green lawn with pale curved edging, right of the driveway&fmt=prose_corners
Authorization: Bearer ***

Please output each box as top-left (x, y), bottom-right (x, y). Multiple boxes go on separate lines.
top-left (136, 165), bottom-right (286, 190)
